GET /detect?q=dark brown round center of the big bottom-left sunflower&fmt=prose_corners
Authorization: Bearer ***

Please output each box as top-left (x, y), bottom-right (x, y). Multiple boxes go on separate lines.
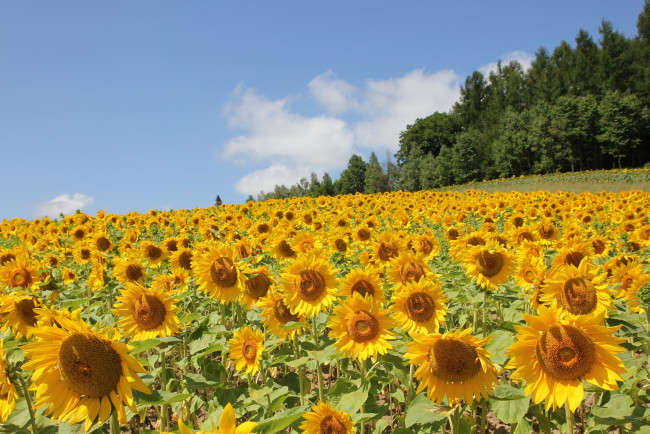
top-left (59, 333), bottom-right (122, 398)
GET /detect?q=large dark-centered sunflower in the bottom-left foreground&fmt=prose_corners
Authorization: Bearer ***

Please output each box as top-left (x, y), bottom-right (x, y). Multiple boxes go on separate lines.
top-left (21, 317), bottom-right (151, 431)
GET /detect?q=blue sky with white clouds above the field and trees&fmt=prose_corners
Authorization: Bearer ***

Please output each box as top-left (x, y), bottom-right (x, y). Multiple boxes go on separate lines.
top-left (0, 0), bottom-right (643, 219)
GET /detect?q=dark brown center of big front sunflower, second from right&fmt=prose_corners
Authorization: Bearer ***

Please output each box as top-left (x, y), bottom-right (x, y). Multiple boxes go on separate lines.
top-left (429, 339), bottom-right (481, 383)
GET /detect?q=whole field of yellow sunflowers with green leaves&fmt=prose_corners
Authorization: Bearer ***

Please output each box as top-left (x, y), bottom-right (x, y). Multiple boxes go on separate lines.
top-left (0, 190), bottom-right (650, 434)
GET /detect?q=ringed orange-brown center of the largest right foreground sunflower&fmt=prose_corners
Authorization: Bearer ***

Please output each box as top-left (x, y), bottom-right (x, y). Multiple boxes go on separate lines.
top-left (535, 325), bottom-right (596, 381)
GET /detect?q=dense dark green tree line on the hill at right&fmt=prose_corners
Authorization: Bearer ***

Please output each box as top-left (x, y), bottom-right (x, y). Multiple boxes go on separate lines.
top-left (249, 0), bottom-right (650, 200)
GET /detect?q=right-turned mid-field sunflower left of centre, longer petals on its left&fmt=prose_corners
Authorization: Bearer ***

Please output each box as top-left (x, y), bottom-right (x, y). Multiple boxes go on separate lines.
top-left (192, 245), bottom-right (244, 303)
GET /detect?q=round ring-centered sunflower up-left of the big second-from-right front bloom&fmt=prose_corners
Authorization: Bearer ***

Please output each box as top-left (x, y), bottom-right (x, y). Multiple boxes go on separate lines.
top-left (328, 292), bottom-right (395, 361)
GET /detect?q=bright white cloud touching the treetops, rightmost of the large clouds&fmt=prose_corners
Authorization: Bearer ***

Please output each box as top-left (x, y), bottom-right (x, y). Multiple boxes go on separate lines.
top-left (355, 69), bottom-right (460, 151)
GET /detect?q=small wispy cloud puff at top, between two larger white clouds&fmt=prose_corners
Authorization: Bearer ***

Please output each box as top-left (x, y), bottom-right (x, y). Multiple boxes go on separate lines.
top-left (309, 69), bottom-right (359, 114)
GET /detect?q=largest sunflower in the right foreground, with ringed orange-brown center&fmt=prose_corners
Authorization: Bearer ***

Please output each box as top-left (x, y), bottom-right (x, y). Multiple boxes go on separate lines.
top-left (506, 306), bottom-right (626, 411)
